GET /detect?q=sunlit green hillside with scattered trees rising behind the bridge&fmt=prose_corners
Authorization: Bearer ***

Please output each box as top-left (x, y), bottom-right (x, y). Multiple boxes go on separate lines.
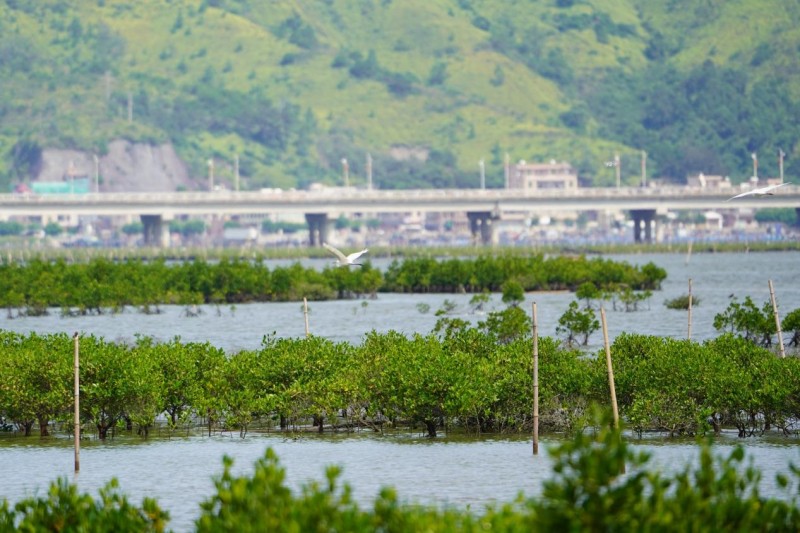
top-left (0, 0), bottom-right (800, 189)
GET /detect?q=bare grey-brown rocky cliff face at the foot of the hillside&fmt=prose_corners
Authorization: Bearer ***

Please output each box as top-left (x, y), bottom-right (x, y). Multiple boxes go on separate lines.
top-left (34, 140), bottom-right (196, 192)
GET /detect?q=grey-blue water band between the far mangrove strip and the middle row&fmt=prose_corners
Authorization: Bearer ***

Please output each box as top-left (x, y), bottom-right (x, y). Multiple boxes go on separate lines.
top-left (0, 252), bottom-right (800, 351)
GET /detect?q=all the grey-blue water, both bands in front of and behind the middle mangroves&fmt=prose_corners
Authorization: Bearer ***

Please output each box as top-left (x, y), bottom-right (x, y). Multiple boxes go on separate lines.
top-left (0, 252), bottom-right (800, 531)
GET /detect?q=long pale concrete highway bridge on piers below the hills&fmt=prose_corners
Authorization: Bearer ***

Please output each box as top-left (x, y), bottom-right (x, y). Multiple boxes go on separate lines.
top-left (0, 185), bottom-right (800, 245)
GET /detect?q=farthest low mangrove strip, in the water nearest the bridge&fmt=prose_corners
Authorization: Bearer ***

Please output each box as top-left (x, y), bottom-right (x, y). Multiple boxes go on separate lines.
top-left (0, 254), bottom-right (666, 316)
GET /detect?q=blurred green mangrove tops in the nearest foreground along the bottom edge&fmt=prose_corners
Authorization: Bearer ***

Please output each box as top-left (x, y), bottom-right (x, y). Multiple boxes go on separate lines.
top-left (0, 416), bottom-right (800, 532)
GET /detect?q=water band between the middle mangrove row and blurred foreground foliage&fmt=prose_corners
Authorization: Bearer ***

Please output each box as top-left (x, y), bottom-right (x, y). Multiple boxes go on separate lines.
top-left (0, 433), bottom-right (800, 531)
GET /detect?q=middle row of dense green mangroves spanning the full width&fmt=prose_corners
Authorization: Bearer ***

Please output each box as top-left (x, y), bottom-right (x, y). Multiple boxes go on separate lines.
top-left (0, 324), bottom-right (800, 439)
